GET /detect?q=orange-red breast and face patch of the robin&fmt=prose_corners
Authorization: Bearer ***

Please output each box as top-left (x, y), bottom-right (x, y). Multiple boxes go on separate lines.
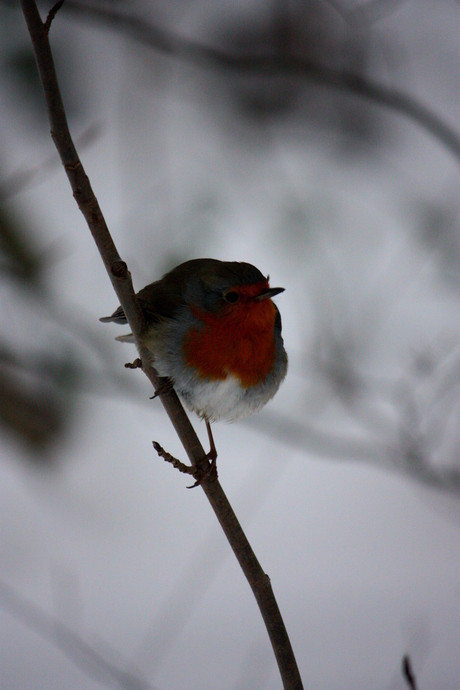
top-left (184, 288), bottom-right (276, 388)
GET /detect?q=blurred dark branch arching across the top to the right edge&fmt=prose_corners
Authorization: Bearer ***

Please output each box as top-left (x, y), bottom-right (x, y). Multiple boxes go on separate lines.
top-left (64, 0), bottom-right (460, 160)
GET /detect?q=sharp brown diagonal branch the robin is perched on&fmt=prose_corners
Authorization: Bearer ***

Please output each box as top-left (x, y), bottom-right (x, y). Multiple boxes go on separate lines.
top-left (21, 0), bottom-right (303, 690)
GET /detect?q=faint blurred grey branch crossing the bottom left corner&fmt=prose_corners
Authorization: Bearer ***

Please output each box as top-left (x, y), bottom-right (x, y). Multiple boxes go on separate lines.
top-left (0, 581), bottom-right (152, 690)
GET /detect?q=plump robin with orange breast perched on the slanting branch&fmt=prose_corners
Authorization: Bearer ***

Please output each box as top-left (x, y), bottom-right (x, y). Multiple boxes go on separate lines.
top-left (100, 259), bottom-right (287, 472)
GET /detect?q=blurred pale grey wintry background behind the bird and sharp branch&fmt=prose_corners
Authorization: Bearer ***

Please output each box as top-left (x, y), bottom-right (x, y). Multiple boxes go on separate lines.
top-left (0, 0), bottom-right (460, 690)
